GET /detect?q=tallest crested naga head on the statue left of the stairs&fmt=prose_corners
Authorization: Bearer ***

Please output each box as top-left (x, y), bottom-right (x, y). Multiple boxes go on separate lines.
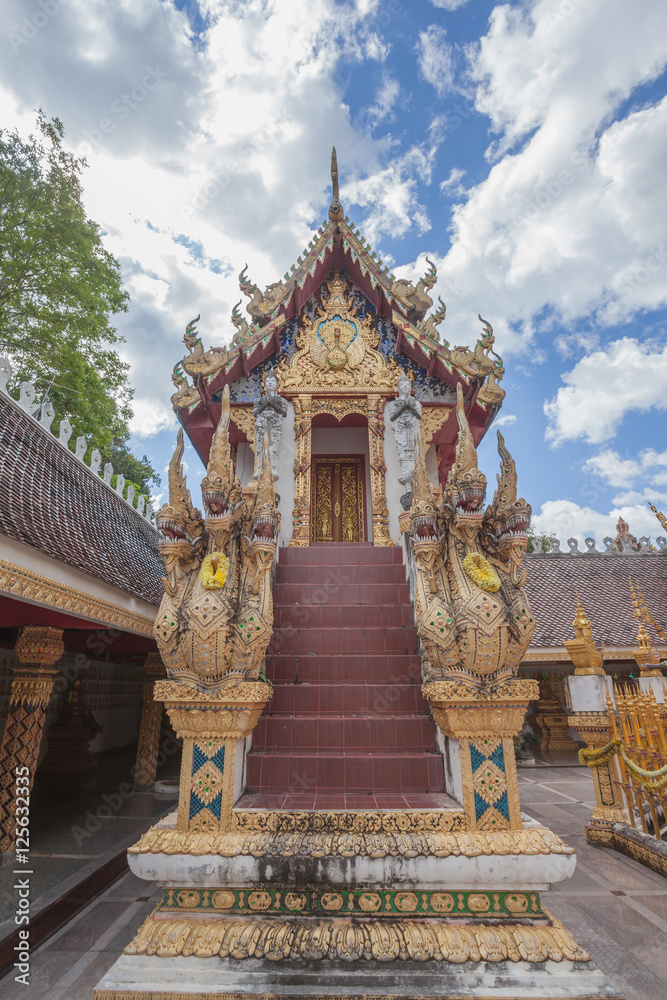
top-left (201, 385), bottom-right (248, 536)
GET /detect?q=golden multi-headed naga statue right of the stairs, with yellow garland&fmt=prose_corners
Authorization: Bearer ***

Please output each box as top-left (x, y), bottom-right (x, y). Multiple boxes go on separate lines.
top-left (410, 384), bottom-right (535, 698)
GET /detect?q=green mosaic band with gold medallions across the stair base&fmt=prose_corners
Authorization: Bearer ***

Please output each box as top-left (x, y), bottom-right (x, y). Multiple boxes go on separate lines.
top-left (161, 888), bottom-right (543, 919)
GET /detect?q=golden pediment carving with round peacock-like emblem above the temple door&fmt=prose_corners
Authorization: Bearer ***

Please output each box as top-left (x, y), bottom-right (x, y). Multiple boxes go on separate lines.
top-left (276, 272), bottom-right (401, 396)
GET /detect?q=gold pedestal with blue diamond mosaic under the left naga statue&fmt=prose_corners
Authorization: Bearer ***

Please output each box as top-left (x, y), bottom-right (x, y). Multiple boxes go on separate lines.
top-left (155, 681), bottom-right (273, 835)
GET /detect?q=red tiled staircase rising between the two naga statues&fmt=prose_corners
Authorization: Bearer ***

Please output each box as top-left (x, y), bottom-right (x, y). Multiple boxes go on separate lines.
top-left (238, 544), bottom-right (451, 809)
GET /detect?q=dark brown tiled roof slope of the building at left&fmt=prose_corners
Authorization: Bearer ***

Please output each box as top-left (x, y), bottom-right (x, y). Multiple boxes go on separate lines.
top-left (0, 394), bottom-right (163, 605)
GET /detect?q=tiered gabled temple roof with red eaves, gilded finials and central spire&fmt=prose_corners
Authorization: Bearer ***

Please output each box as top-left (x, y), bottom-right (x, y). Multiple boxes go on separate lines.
top-left (172, 149), bottom-right (505, 470)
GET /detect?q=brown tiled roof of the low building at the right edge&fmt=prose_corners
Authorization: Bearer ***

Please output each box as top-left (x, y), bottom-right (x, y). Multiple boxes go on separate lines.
top-left (524, 552), bottom-right (667, 648)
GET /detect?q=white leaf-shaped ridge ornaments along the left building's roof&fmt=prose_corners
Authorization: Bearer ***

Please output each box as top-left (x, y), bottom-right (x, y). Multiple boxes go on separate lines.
top-left (0, 357), bottom-right (158, 533)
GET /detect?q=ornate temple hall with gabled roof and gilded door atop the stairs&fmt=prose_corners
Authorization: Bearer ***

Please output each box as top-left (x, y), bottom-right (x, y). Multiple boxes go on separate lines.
top-left (172, 151), bottom-right (505, 547)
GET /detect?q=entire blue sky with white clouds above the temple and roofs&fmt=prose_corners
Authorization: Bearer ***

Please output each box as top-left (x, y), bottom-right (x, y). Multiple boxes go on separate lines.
top-left (0, 0), bottom-right (667, 540)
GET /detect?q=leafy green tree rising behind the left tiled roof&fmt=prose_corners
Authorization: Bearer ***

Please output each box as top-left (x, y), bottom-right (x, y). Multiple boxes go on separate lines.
top-left (0, 110), bottom-right (160, 492)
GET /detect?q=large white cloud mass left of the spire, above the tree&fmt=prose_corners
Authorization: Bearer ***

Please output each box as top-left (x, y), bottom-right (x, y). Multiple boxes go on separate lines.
top-left (0, 0), bottom-right (396, 435)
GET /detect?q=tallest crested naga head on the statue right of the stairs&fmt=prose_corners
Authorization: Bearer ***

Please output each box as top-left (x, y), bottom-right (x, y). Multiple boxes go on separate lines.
top-left (444, 382), bottom-right (486, 541)
